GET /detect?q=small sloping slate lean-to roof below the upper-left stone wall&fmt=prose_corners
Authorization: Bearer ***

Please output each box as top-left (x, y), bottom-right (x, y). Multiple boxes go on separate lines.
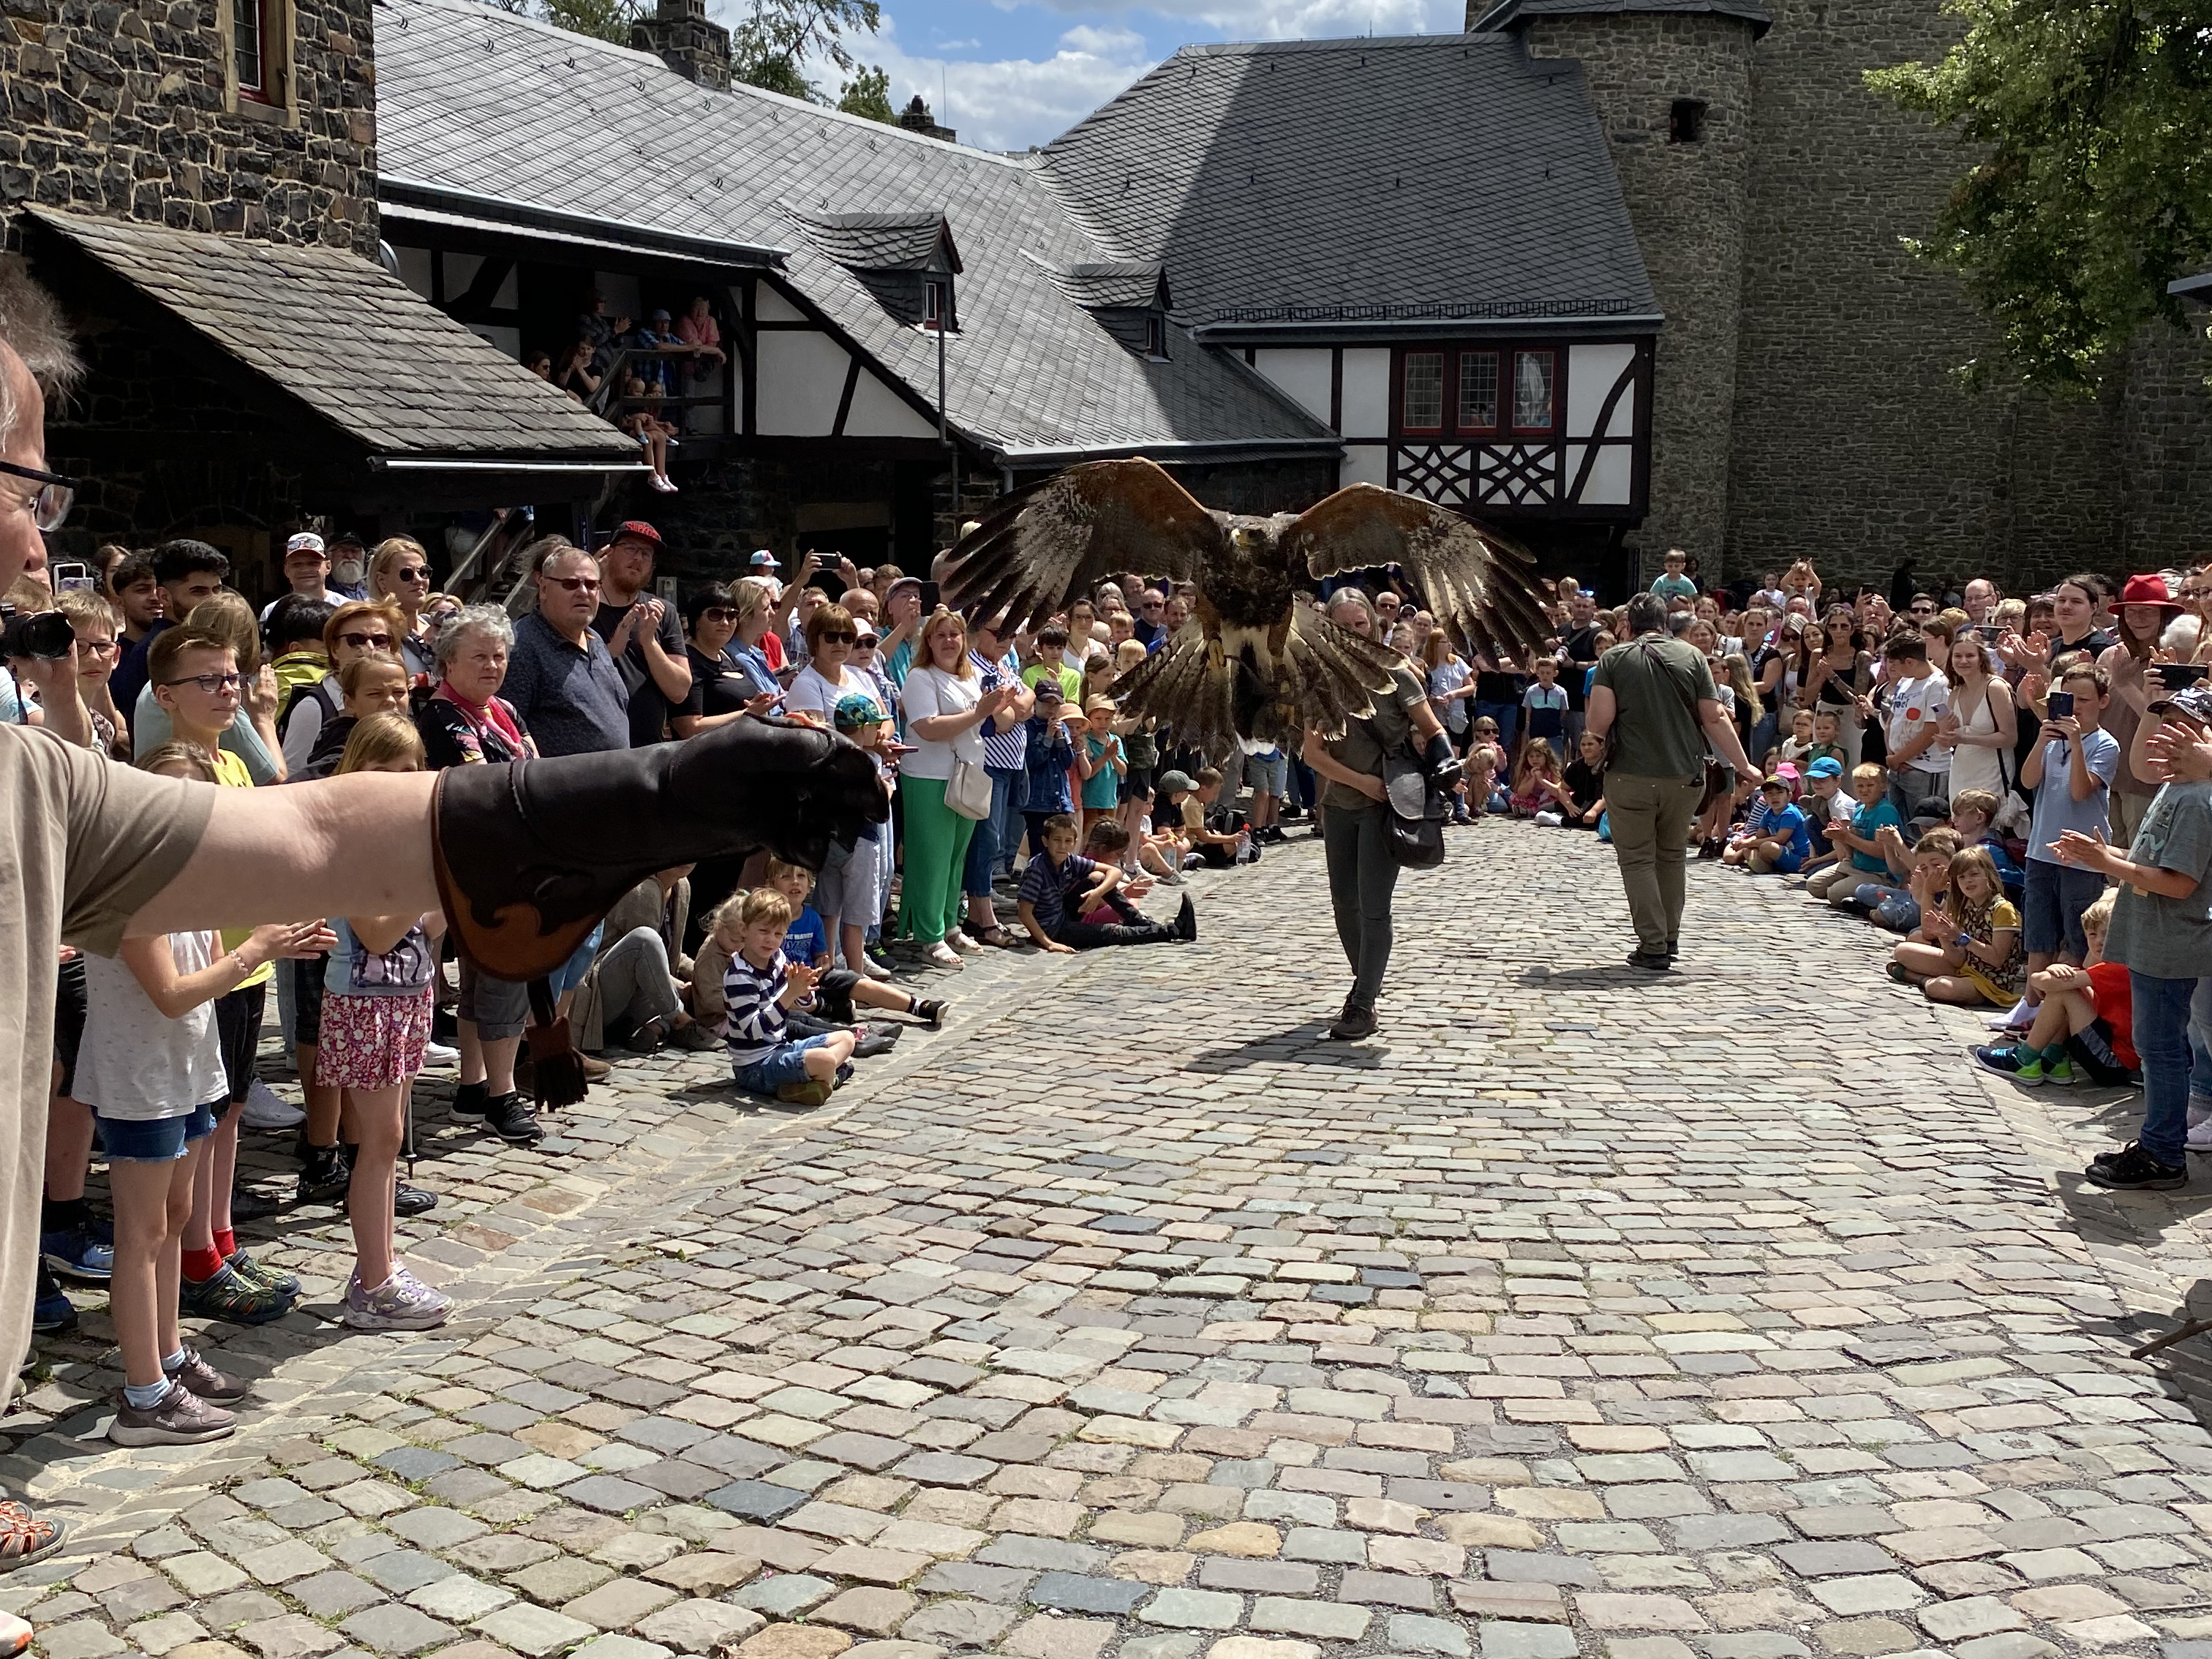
top-left (24, 208), bottom-right (637, 464)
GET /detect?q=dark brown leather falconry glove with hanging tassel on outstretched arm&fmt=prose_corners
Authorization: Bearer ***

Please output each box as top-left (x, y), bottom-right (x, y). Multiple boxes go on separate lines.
top-left (432, 717), bottom-right (892, 1106)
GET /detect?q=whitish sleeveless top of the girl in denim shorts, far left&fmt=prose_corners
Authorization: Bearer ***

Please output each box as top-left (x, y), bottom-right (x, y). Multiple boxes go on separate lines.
top-left (73, 933), bottom-right (230, 1121)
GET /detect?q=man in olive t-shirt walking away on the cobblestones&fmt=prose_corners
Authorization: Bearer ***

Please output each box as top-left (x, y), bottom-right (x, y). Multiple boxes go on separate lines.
top-left (1588, 592), bottom-right (1752, 971)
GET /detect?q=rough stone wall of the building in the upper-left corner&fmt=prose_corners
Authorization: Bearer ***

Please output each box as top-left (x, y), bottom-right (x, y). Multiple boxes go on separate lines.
top-left (0, 0), bottom-right (376, 257)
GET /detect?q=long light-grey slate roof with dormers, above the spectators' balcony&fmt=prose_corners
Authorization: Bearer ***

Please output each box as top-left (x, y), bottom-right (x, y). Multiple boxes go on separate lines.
top-left (376, 0), bottom-right (1336, 458)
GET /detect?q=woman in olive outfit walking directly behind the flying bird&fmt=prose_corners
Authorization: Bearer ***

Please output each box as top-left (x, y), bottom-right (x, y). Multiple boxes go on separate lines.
top-left (1305, 588), bottom-right (1453, 1042)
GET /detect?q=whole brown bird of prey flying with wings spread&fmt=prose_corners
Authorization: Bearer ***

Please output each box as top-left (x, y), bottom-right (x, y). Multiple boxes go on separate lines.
top-left (938, 460), bottom-right (1551, 756)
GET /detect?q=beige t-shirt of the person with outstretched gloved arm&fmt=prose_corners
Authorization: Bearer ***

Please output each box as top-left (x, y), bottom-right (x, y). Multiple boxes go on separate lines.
top-left (0, 726), bottom-right (214, 1376)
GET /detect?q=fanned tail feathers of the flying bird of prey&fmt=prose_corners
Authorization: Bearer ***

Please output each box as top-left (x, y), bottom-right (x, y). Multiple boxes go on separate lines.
top-left (1113, 600), bottom-right (1404, 761)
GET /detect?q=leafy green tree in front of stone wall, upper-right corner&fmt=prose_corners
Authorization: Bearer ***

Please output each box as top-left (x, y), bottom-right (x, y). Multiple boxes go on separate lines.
top-left (1867, 0), bottom-right (2212, 389)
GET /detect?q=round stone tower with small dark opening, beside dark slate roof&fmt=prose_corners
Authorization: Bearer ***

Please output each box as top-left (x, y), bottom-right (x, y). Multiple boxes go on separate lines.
top-left (1524, 15), bottom-right (1752, 571)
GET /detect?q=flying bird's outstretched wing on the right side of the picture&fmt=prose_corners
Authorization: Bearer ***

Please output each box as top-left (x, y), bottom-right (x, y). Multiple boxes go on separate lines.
top-left (1283, 484), bottom-right (1553, 657)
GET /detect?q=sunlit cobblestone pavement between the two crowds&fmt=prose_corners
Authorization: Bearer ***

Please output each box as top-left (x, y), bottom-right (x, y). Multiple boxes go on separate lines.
top-left (12, 823), bottom-right (2212, 1659)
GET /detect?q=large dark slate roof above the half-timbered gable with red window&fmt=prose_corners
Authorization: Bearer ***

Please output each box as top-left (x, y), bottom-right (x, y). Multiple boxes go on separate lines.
top-left (1042, 35), bottom-right (1659, 326)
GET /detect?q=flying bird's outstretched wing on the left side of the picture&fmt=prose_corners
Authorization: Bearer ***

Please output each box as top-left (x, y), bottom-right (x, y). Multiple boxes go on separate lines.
top-left (938, 460), bottom-right (1225, 626)
